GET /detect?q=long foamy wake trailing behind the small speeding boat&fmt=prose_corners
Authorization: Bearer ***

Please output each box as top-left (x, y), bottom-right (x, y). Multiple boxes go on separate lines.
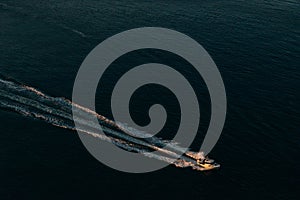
top-left (0, 77), bottom-right (217, 171)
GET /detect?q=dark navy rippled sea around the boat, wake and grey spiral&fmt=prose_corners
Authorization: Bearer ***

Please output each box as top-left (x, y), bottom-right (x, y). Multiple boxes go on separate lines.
top-left (0, 0), bottom-right (300, 199)
